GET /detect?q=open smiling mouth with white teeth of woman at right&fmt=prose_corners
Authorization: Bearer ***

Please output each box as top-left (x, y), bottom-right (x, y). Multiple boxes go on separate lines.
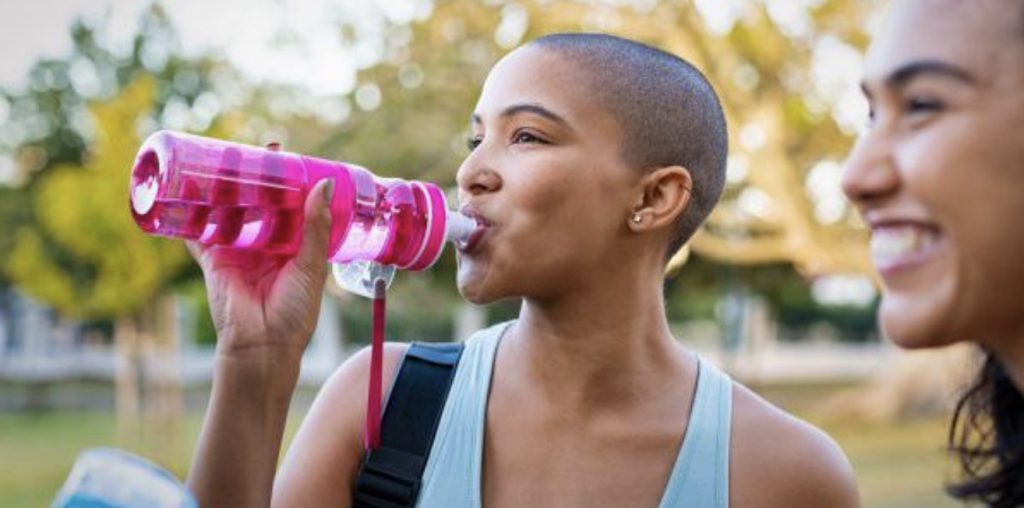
top-left (870, 221), bottom-right (942, 277)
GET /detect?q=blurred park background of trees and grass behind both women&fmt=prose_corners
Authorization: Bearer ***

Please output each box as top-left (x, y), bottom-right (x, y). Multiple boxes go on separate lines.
top-left (0, 0), bottom-right (976, 507)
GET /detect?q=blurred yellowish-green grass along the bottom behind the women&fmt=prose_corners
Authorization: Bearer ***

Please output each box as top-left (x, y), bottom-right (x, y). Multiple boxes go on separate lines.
top-left (0, 403), bottom-right (958, 508)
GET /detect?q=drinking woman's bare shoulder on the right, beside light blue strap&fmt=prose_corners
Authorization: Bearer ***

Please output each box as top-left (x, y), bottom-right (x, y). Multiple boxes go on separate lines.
top-left (730, 383), bottom-right (859, 507)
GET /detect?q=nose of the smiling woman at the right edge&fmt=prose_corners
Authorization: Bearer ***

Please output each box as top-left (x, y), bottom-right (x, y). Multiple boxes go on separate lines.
top-left (842, 130), bottom-right (900, 208)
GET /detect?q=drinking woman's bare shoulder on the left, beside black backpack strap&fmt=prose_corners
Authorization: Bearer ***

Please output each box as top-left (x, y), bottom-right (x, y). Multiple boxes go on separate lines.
top-left (273, 343), bottom-right (409, 506)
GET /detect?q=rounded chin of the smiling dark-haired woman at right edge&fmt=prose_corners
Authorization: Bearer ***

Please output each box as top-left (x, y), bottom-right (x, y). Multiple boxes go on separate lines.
top-left (879, 288), bottom-right (959, 349)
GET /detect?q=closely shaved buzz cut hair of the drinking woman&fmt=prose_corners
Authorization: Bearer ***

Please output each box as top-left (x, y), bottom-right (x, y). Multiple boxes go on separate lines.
top-left (530, 33), bottom-right (729, 259)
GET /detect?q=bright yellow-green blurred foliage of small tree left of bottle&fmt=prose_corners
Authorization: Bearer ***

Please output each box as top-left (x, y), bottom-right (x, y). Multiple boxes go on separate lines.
top-left (8, 79), bottom-right (187, 318)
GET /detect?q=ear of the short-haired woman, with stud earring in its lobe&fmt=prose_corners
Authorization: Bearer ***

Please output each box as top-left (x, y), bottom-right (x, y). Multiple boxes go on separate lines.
top-left (628, 166), bottom-right (693, 231)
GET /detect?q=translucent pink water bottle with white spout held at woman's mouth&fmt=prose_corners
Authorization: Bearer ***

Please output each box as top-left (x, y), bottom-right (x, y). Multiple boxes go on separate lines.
top-left (131, 131), bottom-right (476, 296)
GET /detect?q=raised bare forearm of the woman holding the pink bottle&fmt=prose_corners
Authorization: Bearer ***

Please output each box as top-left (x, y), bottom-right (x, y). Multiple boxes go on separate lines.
top-left (188, 354), bottom-right (299, 507)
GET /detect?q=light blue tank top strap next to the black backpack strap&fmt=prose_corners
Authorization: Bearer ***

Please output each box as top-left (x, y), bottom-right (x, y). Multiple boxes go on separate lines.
top-left (417, 322), bottom-right (512, 508)
